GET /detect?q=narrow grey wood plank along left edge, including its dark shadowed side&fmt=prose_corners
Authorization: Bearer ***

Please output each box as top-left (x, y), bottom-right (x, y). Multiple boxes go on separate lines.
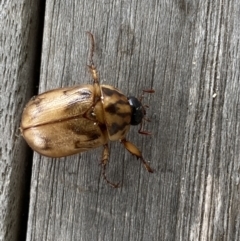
top-left (0, 0), bottom-right (43, 241)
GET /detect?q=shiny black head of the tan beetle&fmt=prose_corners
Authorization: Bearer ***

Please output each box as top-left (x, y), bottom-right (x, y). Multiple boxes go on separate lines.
top-left (128, 96), bottom-right (144, 125)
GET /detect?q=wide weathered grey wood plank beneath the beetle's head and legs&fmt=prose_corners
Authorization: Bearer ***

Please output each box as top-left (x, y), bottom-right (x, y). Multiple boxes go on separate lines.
top-left (27, 0), bottom-right (240, 241)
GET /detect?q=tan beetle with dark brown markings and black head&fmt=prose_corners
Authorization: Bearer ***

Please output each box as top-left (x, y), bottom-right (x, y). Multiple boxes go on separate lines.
top-left (20, 32), bottom-right (154, 188)
